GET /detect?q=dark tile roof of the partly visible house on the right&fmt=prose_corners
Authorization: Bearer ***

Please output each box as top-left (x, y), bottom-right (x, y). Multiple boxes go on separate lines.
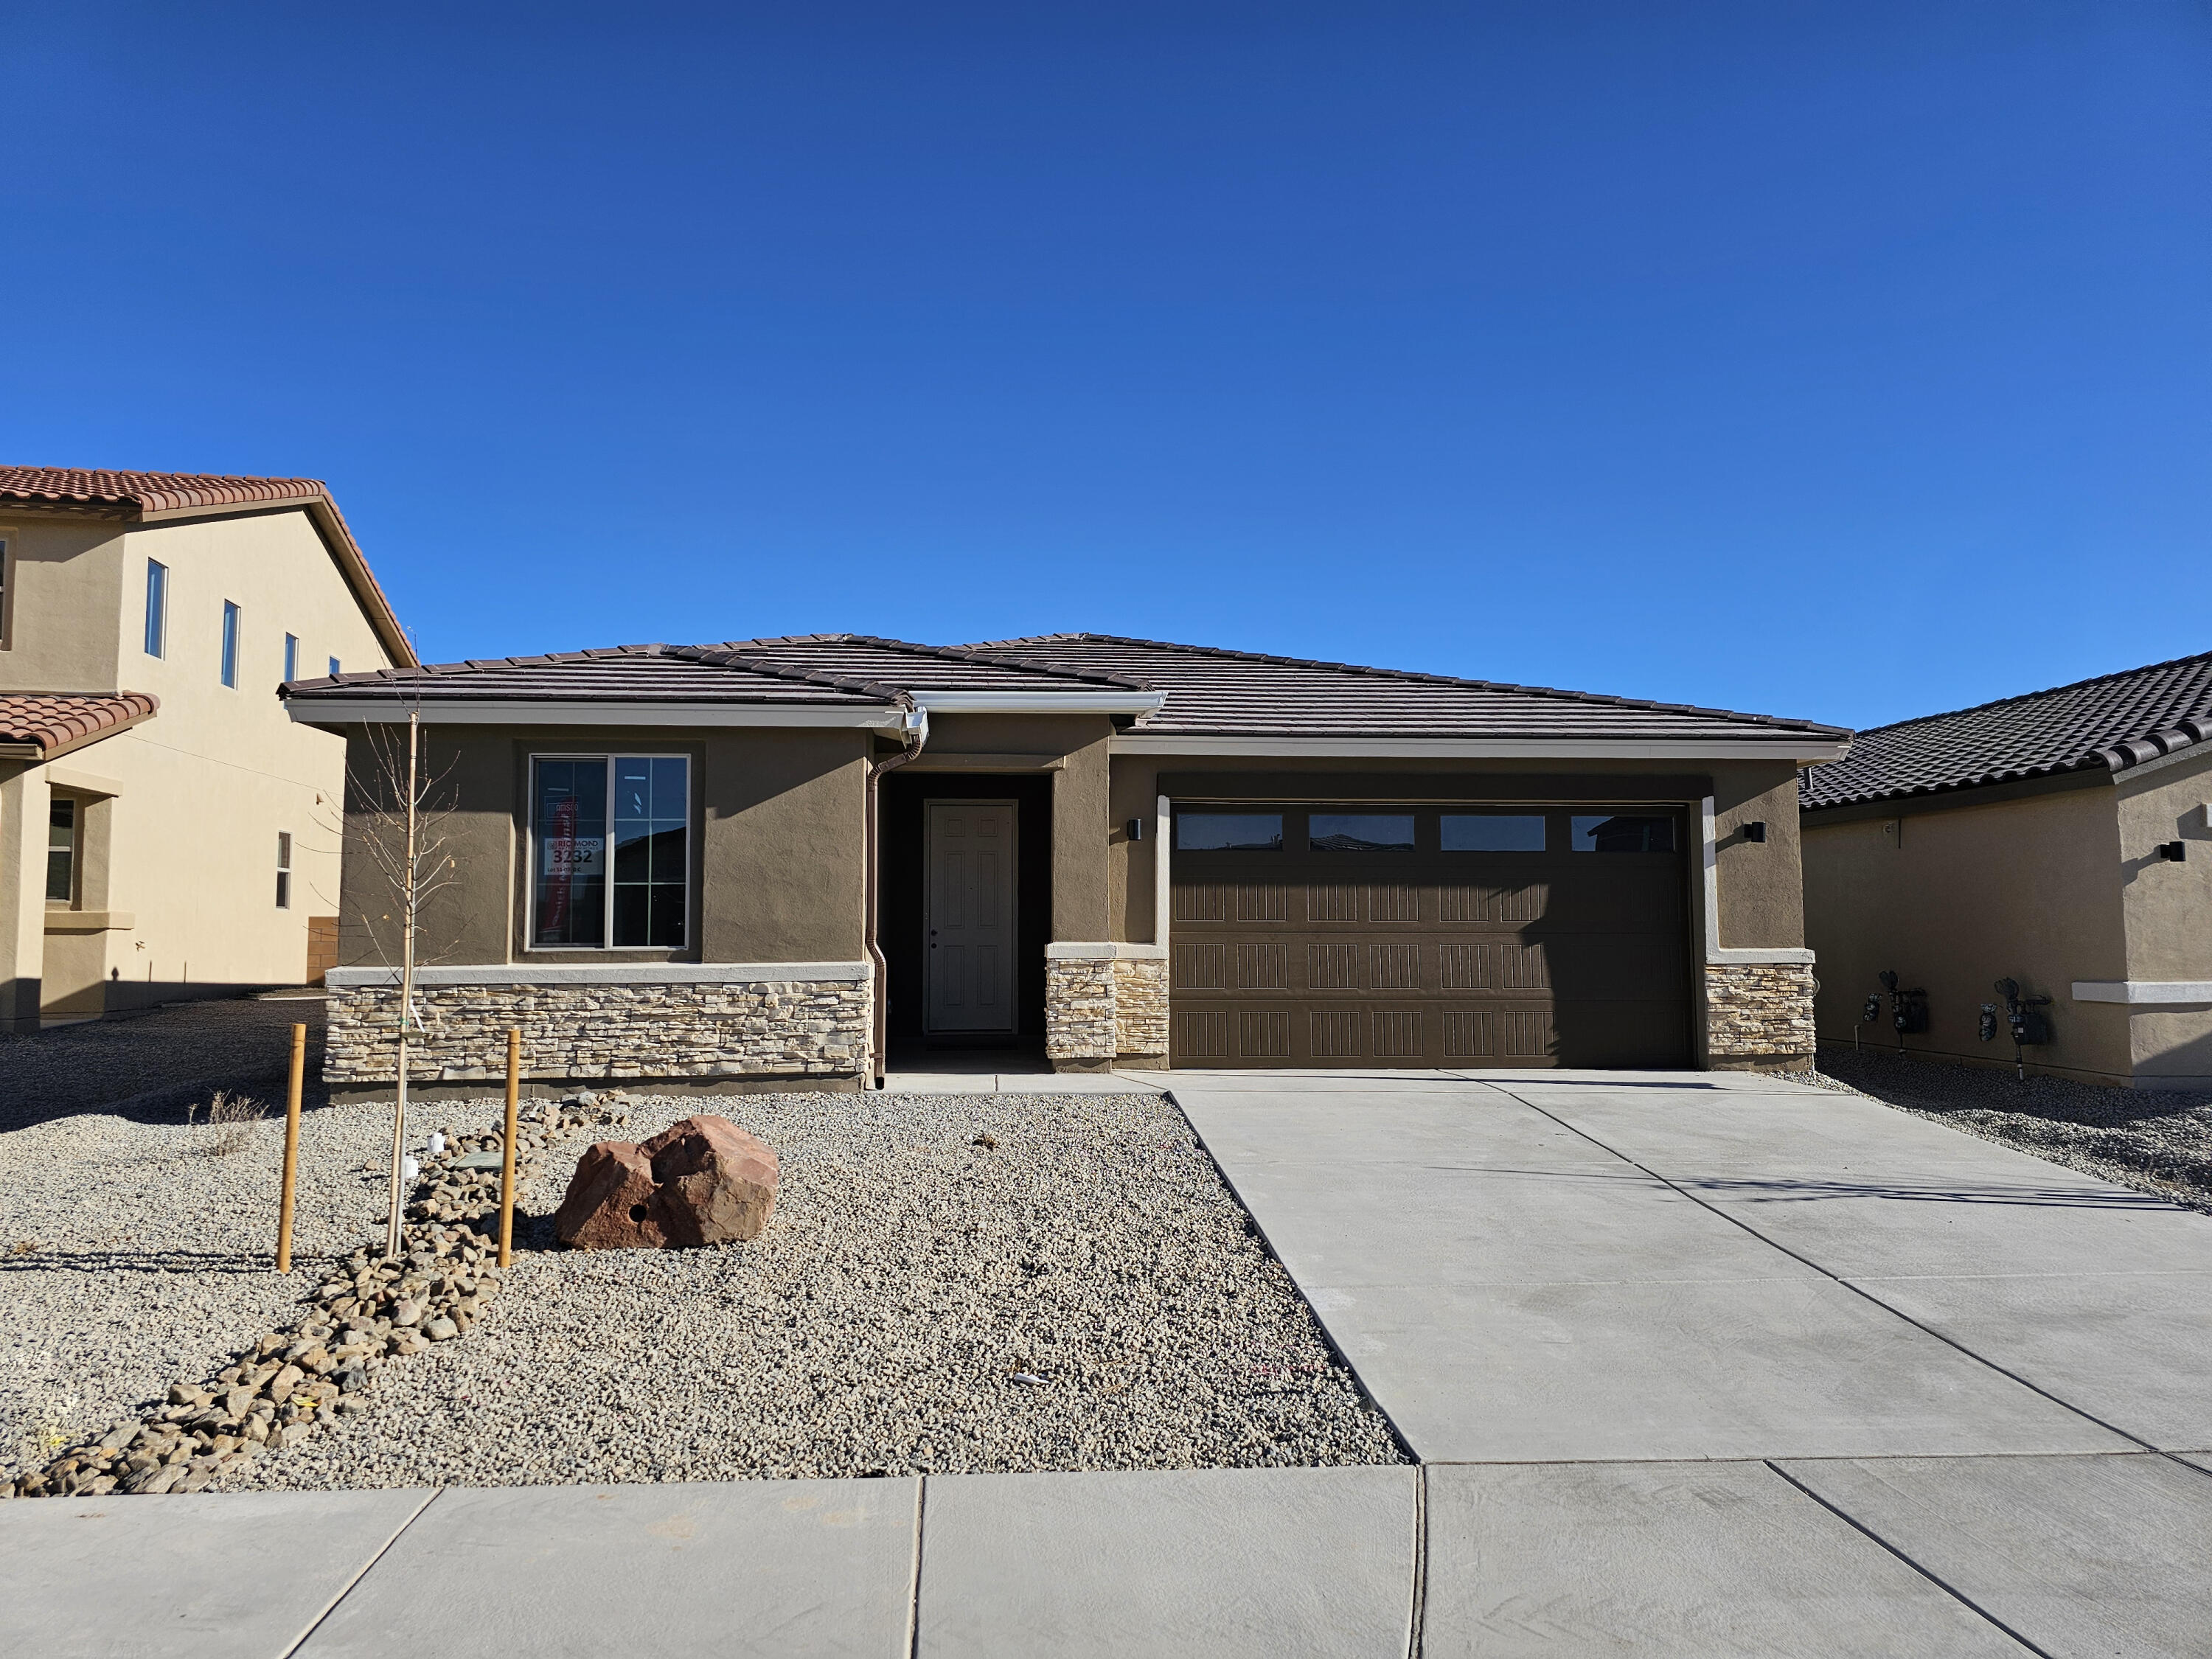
top-left (1798, 653), bottom-right (2212, 810)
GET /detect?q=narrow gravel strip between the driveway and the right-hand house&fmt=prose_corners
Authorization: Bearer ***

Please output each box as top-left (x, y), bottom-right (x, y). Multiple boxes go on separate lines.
top-left (1820, 1044), bottom-right (2212, 1210)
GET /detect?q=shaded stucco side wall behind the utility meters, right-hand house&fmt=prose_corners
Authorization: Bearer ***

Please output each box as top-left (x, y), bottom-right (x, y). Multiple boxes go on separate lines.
top-left (1803, 783), bottom-right (2132, 1082)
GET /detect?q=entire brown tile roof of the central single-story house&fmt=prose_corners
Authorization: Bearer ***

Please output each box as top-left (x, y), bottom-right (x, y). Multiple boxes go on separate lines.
top-left (285, 635), bottom-right (1849, 745)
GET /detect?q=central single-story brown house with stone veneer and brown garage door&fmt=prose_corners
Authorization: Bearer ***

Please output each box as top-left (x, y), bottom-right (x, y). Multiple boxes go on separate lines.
top-left (285, 635), bottom-right (1849, 1099)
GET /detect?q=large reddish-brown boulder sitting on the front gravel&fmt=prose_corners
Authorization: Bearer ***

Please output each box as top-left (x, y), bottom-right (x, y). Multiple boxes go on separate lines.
top-left (553, 1117), bottom-right (776, 1250)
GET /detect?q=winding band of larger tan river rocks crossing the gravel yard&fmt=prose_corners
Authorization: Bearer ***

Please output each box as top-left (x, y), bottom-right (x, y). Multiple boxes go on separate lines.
top-left (0, 1091), bottom-right (630, 1498)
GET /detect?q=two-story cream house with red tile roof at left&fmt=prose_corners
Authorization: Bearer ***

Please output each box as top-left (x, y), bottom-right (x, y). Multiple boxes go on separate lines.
top-left (0, 467), bottom-right (416, 1031)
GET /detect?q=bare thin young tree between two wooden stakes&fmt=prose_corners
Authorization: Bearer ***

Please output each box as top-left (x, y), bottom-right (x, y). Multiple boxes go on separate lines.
top-left (345, 710), bottom-right (458, 1256)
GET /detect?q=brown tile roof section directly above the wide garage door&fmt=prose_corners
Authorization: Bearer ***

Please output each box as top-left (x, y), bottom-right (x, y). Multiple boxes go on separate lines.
top-left (973, 633), bottom-right (1849, 743)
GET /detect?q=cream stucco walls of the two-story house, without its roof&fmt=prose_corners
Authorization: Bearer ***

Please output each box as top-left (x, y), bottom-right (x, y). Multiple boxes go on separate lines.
top-left (0, 511), bottom-right (387, 1013)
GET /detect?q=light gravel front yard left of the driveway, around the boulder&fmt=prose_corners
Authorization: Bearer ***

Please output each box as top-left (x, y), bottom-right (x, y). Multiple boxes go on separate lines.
top-left (0, 1079), bottom-right (1405, 1489)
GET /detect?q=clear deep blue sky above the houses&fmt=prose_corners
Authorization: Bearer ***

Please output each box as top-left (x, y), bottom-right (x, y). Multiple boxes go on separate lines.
top-left (0, 0), bottom-right (2212, 726)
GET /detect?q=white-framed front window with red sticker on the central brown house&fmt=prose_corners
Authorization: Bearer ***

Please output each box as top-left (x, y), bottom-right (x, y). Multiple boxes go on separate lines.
top-left (531, 754), bottom-right (690, 949)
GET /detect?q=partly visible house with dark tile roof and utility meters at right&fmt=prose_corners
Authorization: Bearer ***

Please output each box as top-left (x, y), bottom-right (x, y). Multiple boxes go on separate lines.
top-left (1801, 653), bottom-right (2212, 1088)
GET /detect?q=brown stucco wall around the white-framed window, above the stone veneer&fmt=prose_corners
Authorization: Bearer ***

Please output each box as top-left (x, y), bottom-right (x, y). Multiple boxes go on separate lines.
top-left (338, 726), bottom-right (869, 967)
